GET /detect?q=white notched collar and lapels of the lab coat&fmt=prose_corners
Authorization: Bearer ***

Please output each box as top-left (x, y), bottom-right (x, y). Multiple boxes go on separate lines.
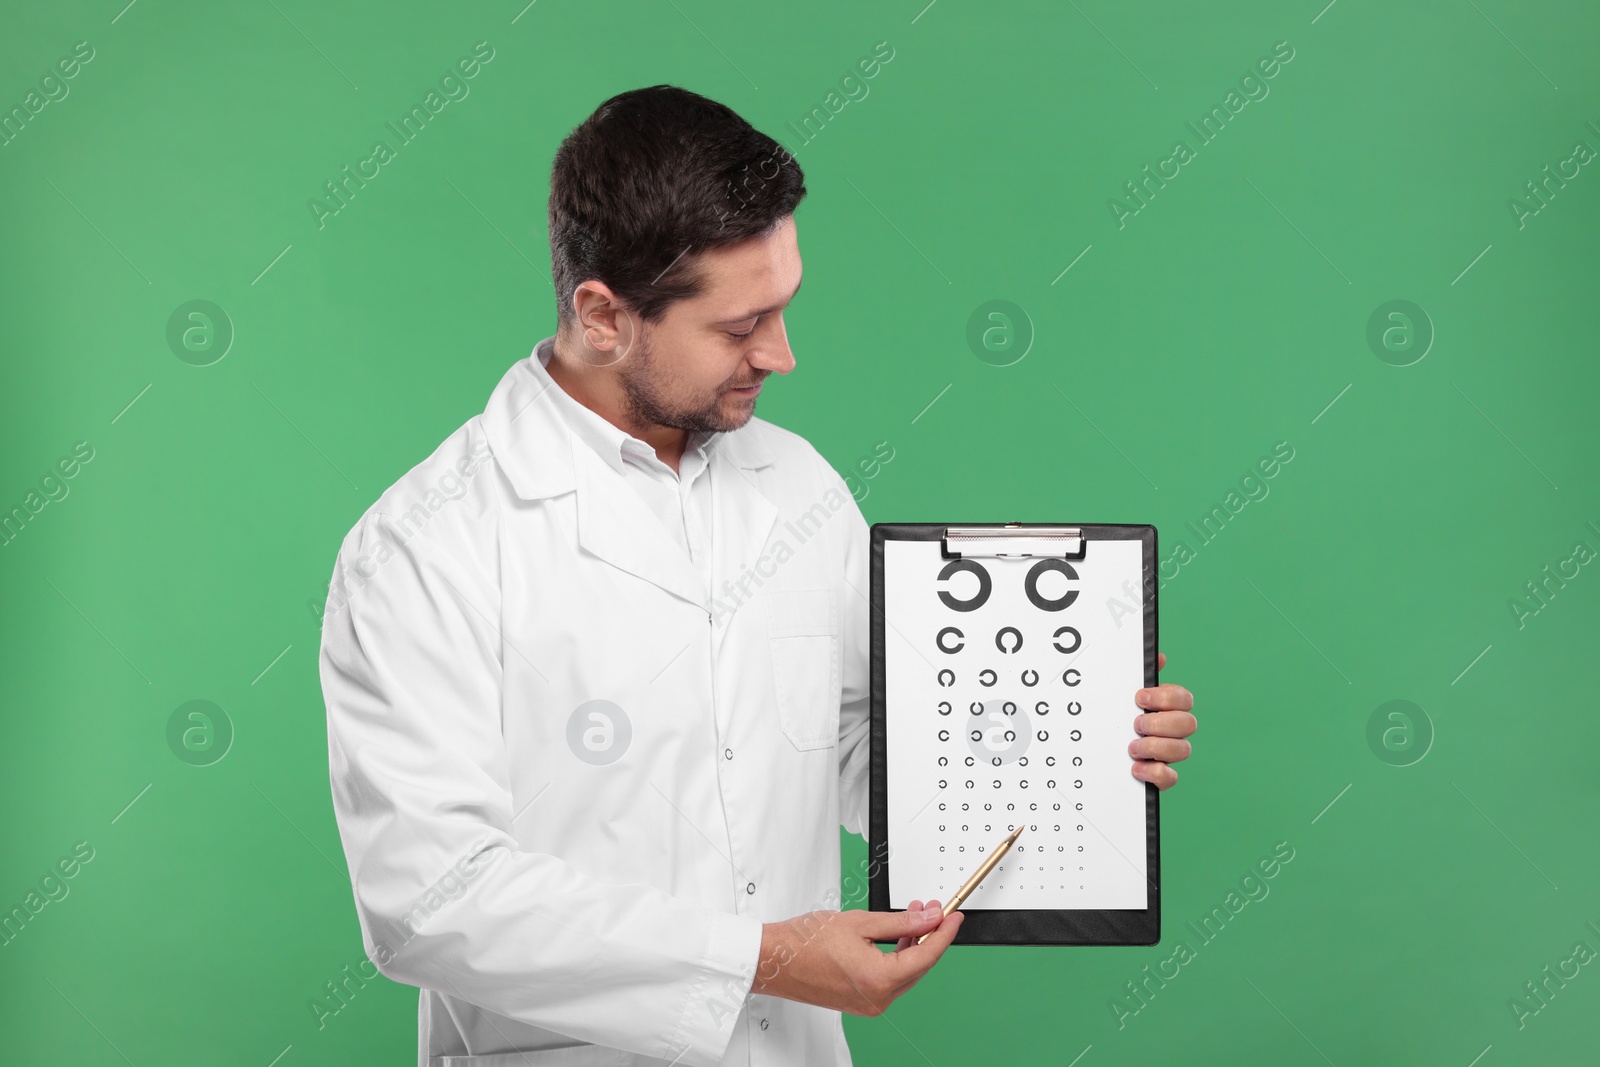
top-left (483, 338), bottom-right (778, 611)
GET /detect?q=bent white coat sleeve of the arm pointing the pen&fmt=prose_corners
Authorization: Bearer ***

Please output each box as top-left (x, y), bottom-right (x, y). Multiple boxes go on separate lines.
top-left (320, 514), bottom-right (762, 1067)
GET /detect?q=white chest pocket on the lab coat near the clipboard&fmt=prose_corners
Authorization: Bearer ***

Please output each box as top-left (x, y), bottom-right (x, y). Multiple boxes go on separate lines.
top-left (766, 589), bottom-right (840, 750)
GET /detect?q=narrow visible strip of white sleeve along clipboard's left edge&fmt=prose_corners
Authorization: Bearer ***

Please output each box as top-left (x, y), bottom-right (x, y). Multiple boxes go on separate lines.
top-left (838, 480), bottom-right (872, 835)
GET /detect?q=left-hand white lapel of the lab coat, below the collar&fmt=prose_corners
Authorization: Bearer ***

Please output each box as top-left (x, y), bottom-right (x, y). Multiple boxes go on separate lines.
top-left (573, 448), bottom-right (707, 611)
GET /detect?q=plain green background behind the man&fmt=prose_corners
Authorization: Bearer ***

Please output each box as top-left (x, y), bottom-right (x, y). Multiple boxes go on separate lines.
top-left (0, 0), bottom-right (1600, 1067)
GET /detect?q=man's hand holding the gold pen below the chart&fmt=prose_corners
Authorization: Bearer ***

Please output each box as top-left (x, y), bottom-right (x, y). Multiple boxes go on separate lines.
top-left (750, 901), bottom-right (962, 1016)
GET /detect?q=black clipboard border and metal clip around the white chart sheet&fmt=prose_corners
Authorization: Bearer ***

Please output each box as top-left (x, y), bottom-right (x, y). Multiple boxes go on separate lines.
top-left (867, 523), bottom-right (1162, 945)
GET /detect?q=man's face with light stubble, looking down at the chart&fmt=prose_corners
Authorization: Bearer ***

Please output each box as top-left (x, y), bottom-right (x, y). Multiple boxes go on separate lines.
top-left (618, 216), bottom-right (800, 434)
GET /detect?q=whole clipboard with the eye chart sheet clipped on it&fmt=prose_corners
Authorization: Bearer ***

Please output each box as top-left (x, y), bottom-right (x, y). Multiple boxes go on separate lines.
top-left (867, 523), bottom-right (1162, 945)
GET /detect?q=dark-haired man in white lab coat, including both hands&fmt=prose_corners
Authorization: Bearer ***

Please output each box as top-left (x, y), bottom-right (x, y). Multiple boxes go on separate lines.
top-left (320, 86), bottom-right (1195, 1067)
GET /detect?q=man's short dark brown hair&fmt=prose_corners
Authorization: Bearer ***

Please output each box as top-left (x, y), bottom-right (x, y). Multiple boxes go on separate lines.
top-left (549, 85), bottom-right (805, 326)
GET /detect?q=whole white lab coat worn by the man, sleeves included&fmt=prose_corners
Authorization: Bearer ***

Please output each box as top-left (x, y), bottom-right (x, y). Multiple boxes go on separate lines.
top-left (322, 342), bottom-right (869, 1067)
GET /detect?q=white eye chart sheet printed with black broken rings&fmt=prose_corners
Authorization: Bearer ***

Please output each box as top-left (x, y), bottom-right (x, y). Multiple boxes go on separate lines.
top-left (883, 541), bottom-right (1149, 910)
